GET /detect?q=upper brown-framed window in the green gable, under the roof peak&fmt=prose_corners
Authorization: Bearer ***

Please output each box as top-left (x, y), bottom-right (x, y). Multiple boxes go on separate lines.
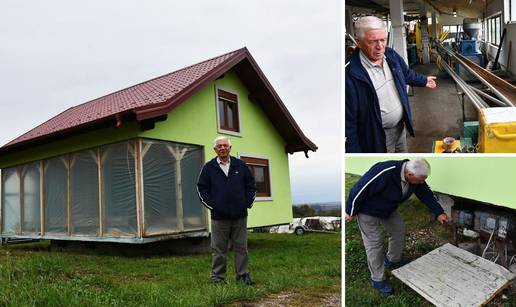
top-left (217, 89), bottom-right (240, 134)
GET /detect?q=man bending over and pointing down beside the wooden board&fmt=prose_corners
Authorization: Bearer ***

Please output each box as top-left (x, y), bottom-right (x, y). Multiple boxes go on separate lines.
top-left (345, 159), bottom-right (448, 295)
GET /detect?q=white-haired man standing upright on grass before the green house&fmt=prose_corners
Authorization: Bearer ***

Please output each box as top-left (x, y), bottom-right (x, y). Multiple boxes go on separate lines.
top-left (197, 136), bottom-right (256, 286)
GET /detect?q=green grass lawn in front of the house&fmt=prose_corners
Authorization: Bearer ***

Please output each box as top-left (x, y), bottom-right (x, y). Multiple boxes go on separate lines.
top-left (0, 233), bottom-right (341, 306)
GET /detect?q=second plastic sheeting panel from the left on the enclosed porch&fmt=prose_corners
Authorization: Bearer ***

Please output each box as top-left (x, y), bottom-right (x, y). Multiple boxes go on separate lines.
top-left (22, 162), bottom-right (41, 234)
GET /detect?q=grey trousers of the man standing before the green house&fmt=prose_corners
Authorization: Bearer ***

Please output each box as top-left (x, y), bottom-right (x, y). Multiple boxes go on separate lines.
top-left (211, 217), bottom-right (249, 280)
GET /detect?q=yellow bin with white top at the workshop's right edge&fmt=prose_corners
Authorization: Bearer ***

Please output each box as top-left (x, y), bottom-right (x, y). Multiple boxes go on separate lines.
top-left (478, 107), bottom-right (516, 153)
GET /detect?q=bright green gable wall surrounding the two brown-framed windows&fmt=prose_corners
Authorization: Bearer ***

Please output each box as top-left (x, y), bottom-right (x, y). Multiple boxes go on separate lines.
top-left (139, 71), bottom-right (292, 227)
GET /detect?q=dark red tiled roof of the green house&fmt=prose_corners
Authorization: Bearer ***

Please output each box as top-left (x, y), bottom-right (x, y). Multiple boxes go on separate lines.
top-left (0, 47), bottom-right (317, 156)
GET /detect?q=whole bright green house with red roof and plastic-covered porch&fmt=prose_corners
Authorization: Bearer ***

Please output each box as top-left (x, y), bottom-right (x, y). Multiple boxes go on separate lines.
top-left (0, 48), bottom-right (317, 243)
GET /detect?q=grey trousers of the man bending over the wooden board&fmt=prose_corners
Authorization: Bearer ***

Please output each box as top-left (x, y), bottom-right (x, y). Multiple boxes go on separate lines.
top-left (357, 211), bottom-right (405, 281)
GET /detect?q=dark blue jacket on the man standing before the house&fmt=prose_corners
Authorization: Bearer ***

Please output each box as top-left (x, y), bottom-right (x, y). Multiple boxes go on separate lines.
top-left (197, 157), bottom-right (256, 220)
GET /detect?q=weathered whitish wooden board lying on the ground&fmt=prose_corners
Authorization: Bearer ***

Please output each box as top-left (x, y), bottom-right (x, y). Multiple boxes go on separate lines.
top-left (392, 244), bottom-right (516, 306)
